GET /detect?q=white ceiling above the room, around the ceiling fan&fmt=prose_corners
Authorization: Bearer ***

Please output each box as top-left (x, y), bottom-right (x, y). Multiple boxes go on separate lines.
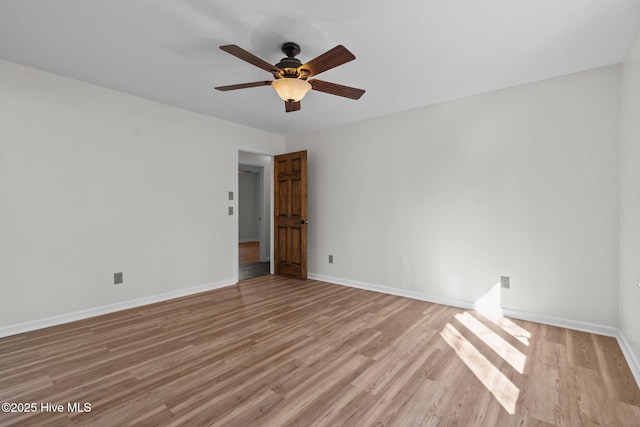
top-left (0, 0), bottom-right (640, 135)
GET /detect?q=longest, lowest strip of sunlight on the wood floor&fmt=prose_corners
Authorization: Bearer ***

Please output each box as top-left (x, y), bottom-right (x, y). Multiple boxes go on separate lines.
top-left (440, 323), bottom-right (520, 414)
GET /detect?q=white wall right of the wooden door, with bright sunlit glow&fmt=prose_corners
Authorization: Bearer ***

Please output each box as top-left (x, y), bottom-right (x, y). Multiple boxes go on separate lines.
top-left (286, 66), bottom-right (624, 327)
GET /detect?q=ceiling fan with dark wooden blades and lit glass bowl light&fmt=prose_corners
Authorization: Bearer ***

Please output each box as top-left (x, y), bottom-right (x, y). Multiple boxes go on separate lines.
top-left (216, 42), bottom-right (365, 113)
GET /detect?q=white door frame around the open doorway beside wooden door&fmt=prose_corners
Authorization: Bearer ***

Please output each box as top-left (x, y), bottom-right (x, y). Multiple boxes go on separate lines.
top-left (235, 145), bottom-right (277, 284)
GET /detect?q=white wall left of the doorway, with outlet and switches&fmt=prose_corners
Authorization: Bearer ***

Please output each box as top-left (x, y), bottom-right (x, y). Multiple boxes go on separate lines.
top-left (0, 61), bottom-right (284, 327)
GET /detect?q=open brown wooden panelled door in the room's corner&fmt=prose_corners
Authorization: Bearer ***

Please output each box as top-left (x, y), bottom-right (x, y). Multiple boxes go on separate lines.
top-left (273, 151), bottom-right (307, 280)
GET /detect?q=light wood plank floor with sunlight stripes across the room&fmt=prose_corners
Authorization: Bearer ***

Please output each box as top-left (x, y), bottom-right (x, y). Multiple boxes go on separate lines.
top-left (0, 276), bottom-right (640, 426)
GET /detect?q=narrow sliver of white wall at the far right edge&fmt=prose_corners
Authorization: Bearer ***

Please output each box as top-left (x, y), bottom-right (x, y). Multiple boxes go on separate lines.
top-left (620, 27), bottom-right (640, 362)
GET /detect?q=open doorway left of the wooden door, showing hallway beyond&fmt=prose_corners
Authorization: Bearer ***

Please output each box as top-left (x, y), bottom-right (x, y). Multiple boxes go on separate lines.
top-left (237, 149), bottom-right (273, 280)
